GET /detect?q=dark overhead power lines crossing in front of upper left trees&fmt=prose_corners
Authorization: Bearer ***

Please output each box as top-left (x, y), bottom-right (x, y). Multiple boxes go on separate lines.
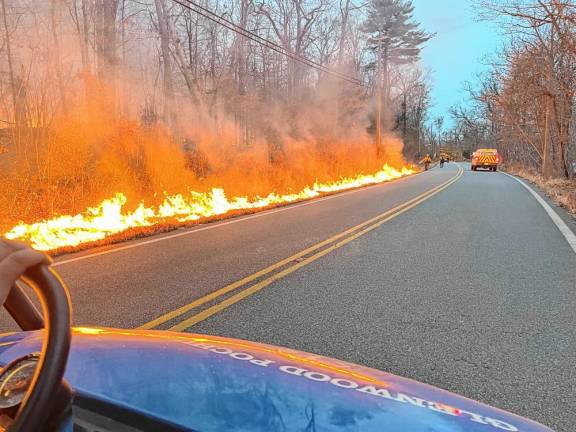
top-left (172, 0), bottom-right (364, 86)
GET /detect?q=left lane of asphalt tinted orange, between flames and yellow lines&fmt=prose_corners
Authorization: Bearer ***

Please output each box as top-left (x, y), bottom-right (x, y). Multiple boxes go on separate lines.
top-left (5, 164), bottom-right (454, 328)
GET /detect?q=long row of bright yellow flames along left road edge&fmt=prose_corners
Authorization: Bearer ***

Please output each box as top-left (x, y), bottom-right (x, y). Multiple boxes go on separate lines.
top-left (5, 165), bottom-right (414, 251)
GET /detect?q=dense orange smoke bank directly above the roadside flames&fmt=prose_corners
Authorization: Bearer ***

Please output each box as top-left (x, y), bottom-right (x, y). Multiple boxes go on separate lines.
top-left (0, 74), bottom-right (404, 228)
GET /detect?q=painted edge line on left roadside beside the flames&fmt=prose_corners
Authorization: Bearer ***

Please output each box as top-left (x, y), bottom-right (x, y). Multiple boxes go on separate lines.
top-left (52, 171), bottom-right (438, 267)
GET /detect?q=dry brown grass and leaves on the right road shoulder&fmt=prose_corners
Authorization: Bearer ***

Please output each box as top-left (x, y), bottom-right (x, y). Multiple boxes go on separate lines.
top-left (505, 166), bottom-right (576, 216)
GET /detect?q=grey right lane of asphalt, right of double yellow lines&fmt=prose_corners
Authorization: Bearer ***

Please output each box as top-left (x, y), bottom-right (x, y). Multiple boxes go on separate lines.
top-left (191, 166), bottom-right (576, 432)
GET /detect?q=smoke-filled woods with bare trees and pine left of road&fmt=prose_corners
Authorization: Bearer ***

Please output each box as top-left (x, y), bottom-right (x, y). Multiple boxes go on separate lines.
top-left (0, 0), bottom-right (433, 246)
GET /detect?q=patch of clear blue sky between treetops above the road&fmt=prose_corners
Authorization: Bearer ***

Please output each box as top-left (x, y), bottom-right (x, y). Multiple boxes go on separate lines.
top-left (412, 0), bottom-right (501, 127)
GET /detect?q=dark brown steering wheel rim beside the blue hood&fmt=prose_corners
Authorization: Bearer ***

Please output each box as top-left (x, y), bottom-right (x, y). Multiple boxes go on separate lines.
top-left (3, 265), bottom-right (72, 432)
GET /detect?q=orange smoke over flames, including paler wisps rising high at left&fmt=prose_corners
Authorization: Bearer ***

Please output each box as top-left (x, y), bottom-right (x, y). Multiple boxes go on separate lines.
top-left (0, 2), bottom-right (405, 232)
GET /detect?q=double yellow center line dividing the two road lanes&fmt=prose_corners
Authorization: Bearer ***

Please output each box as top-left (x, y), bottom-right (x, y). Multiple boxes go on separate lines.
top-left (139, 166), bottom-right (464, 331)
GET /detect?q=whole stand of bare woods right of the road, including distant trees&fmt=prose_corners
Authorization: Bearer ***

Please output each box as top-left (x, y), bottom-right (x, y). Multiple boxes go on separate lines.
top-left (450, 0), bottom-right (576, 182)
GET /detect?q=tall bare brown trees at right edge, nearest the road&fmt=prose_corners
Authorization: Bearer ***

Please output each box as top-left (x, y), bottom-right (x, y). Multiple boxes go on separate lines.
top-left (477, 0), bottom-right (576, 177)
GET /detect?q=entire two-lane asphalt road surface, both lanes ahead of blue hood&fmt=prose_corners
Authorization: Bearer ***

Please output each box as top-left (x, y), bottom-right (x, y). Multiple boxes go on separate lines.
top-left (0, 164), bottom-right (576, 432)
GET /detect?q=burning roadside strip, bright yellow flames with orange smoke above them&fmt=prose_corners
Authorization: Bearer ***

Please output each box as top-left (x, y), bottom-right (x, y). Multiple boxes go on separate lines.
top-left (0, 81), bottom-right (414, 253)
